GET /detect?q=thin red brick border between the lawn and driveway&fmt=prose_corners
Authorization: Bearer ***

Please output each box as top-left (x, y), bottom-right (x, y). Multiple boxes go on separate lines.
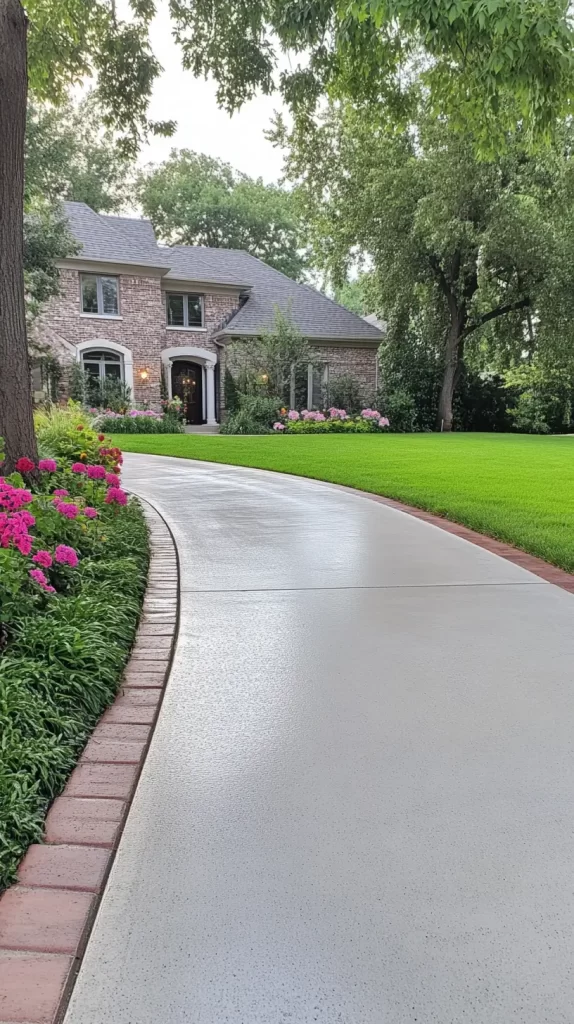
top-left (335, 483), bottom-right (574, 594)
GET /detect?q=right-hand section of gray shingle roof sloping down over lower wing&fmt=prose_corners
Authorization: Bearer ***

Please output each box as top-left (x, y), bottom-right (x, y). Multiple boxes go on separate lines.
top-left (164, 246), bottom-right (383, 342)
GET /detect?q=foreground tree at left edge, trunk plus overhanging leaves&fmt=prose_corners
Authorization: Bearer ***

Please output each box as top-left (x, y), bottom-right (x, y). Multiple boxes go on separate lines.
top-left (0, 0), bottom-right (172, 469)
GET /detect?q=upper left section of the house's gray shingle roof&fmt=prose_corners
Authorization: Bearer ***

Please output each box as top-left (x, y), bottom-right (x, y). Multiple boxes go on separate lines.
top-left (63, 203), bottom-right (169, 267)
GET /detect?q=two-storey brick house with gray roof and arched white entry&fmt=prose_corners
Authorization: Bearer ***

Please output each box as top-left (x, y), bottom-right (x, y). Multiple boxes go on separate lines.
top-left (36, 203), bottom-right (383, 426)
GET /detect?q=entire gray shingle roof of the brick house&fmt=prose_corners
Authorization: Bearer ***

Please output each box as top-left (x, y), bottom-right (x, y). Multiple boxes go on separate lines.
top-left (64, 203), bottom-right (383, 343)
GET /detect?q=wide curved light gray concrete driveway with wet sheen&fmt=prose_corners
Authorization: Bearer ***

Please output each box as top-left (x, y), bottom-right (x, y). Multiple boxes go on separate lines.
top-left (65, 456), bottom-right (574, 1024)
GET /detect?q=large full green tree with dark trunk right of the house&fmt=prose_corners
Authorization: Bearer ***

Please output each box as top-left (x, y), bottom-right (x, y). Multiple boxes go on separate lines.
top-left (277, 100), bottom-right (574, 430)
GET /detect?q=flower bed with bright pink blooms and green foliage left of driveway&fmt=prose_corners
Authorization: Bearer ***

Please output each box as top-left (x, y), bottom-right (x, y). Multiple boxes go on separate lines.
top-left (0, 448), bottom-right (148, 888)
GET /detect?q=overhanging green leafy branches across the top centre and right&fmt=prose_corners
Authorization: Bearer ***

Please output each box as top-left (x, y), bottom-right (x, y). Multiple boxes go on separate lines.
top-left (171, 0), bottom-right (574, 148)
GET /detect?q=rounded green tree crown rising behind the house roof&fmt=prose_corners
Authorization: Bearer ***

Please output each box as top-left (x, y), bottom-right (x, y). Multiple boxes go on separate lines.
top-left (138, 150), bottom-right (304, 279)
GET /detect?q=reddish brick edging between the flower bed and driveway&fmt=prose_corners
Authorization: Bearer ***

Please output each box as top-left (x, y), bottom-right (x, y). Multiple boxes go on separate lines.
top-left (0, 500), bottom-right (179, 1024)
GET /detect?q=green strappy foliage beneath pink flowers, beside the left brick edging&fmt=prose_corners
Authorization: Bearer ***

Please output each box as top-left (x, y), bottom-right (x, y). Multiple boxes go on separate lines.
top-left (0, 464), bottom-right (148, 890)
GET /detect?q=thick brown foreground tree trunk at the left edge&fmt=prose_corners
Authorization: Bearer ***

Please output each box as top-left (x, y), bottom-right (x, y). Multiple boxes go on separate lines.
top-left (0, 0), bottom-right (37, 471)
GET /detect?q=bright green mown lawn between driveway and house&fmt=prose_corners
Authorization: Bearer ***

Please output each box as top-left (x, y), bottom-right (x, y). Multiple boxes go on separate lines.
top-left (114, 433), bottom-right (574, 571)
